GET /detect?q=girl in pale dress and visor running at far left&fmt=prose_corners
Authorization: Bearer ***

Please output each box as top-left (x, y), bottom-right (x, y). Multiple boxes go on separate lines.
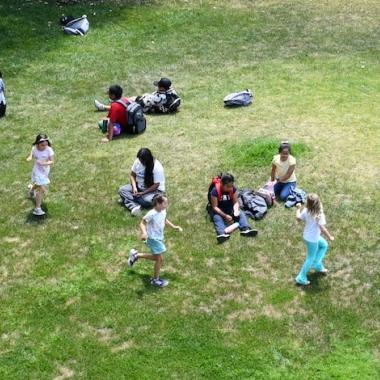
top-left (26, 134), bottom-right (54, 216)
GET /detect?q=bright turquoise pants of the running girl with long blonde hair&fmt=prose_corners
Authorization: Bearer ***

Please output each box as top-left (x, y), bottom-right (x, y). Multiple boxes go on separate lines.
top-left (296, 237), bottom-right (329, 284)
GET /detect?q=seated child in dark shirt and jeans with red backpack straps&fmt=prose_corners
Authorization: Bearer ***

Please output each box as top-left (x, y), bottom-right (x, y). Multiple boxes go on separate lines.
top-left (210, 174), bottom-right (257, 244)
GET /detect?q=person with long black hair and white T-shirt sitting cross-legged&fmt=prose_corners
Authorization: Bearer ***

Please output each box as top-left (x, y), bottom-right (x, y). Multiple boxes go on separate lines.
top-left (119, 148), bottom-right (165, 216)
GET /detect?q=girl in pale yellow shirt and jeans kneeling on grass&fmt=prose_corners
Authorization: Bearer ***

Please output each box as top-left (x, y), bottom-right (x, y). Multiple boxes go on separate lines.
top-left (271, 141), bottom-right (297, 201)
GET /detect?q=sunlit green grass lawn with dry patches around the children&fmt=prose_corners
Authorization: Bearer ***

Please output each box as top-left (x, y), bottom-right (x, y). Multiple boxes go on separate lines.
top-left (0, 0), bottom-right (380, 380)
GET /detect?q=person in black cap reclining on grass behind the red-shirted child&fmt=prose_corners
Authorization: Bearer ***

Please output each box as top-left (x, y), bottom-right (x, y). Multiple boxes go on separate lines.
top-left (94, 78), bottom-right (181, 114)
